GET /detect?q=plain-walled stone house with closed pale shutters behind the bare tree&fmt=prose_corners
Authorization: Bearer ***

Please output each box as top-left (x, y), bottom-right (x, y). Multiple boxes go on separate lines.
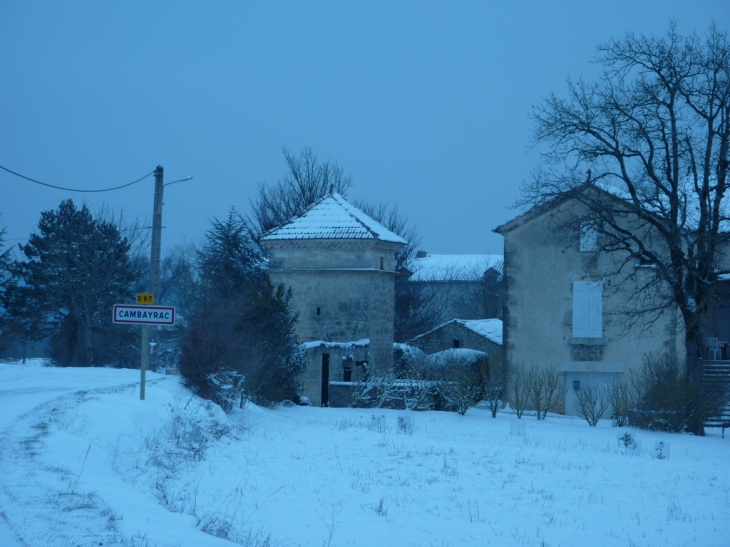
top-left (495, 188), bottom-right (685, 414)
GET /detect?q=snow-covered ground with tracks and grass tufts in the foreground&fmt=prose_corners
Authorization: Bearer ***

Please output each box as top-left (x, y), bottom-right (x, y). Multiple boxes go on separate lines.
top-left (0, 363), bottom-right (730, 547)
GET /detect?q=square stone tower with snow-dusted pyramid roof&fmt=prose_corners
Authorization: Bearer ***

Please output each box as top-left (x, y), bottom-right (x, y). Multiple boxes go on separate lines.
top-left (262, 193), bottom-right (408, 406)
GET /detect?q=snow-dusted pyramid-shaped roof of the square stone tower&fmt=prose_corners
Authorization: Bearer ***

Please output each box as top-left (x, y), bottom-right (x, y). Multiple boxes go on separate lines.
top-left (262, 193), bottom-right (408, 245)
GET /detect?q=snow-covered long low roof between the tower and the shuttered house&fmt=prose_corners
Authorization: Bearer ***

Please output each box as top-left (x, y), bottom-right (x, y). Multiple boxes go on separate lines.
top-left (411, 253), bottom-right (504, 281)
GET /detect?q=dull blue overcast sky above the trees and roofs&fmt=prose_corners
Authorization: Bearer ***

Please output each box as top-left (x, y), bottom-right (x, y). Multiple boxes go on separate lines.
top-left (0, 0), bottom-right (730, 253)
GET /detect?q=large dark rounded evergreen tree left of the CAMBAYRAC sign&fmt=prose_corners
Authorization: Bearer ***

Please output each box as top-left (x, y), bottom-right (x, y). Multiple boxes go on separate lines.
top-left (8, 200), bottom-right (133, 366)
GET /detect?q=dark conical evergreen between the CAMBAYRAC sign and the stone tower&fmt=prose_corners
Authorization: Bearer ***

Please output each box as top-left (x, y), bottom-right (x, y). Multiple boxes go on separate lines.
top-left (180, 210), bottom-right (305, 409)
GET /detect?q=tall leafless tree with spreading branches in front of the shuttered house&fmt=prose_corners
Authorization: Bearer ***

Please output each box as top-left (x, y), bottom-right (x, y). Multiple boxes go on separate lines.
top-left (522, 22), bottom-right (730, 373)
